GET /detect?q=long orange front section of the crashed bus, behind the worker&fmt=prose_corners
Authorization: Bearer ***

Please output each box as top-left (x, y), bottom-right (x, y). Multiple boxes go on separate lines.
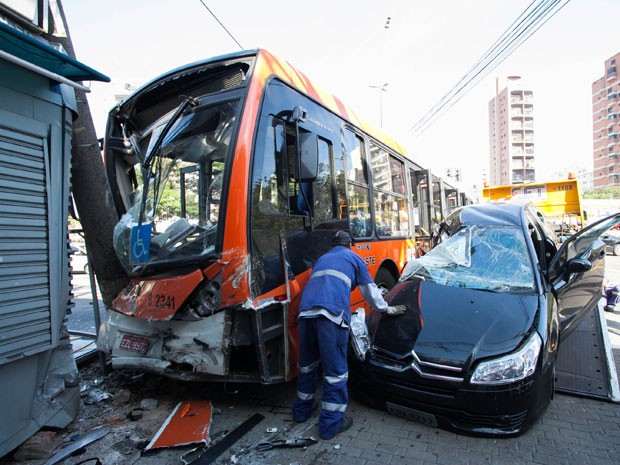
top-left (97, 50), bottom-right (421, 384)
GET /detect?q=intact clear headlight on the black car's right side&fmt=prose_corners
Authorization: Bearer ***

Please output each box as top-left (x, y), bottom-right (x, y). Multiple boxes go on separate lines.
top-left (471, 332), bottom-right (542, 384)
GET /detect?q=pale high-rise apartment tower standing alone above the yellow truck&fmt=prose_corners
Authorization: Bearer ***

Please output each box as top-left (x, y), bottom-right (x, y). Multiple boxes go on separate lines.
top-left (489, 76), bottom-right (536, 186)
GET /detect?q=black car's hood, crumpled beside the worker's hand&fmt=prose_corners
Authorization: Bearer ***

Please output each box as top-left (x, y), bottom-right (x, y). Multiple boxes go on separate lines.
top-left (368, 277), bottom-right (539, 368)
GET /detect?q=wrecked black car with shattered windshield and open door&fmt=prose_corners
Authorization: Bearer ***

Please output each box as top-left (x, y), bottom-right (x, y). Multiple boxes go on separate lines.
top-left (350, 204), bottom-right (620, 436)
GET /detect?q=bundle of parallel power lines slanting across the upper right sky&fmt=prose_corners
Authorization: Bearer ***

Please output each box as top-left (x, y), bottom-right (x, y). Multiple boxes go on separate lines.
top-left (411, 0), bottom-right (570, 134)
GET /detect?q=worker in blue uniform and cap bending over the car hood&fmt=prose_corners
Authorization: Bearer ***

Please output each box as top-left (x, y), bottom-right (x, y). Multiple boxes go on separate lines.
top-left (293, 231), bottom-right (406, 440)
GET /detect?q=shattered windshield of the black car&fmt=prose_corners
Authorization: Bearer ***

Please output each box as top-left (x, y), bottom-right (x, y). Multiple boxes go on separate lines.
top-left (401, 226), bottom-right (535, 292)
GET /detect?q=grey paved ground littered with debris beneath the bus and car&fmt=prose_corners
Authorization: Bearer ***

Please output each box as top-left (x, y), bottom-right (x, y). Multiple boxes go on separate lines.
top-left (10, 262), bottom-right (620, 465)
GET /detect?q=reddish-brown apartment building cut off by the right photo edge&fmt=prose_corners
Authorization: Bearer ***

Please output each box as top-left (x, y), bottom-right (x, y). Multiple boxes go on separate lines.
top-left (592, 53), bottom-right (620, 189)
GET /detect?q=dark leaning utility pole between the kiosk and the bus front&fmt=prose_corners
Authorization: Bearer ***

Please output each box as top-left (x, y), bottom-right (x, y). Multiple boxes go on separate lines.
top-left (53, 0), bottom-right (129, 307)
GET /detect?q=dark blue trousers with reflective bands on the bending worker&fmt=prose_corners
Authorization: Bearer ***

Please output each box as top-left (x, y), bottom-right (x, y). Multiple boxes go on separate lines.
top-left (293, 315), bottom-right (349, 439)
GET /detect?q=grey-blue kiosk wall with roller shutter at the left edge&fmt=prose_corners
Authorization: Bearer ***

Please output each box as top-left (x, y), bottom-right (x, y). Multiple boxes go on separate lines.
top-left (0, 29), bottom-right (108, 457)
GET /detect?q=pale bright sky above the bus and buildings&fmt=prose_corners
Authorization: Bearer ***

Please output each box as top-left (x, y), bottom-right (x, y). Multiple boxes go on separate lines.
top-left (62, 0), bottom-right (620, 195)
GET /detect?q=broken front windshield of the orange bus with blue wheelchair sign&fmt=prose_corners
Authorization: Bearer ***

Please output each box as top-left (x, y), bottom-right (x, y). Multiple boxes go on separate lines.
top-left (114, 100), bottom-right (239, 271)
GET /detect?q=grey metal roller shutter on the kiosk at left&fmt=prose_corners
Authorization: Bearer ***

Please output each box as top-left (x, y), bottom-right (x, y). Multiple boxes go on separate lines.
top-left (0, 122), bottom-right (52, 365)
